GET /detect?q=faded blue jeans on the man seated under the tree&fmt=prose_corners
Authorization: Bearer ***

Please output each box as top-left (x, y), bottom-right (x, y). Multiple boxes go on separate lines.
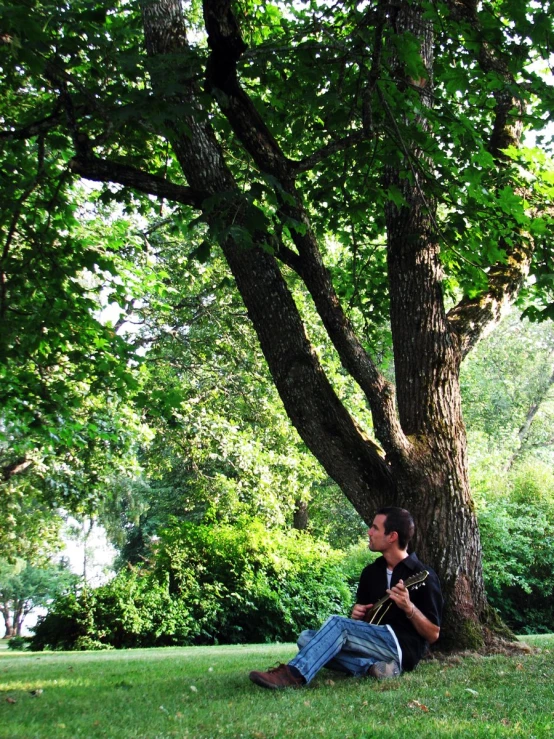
top-left (289, 616), bottom-right (400, 683)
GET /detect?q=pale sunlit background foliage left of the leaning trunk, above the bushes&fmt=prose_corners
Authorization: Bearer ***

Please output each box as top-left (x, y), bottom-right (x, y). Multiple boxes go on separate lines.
top-left (97, 243), bottom-right (368, 563)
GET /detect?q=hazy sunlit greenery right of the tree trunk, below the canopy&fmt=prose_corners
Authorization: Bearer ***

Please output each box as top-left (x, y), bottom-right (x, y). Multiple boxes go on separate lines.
top-left (454, 315), bottom-right (554, 633)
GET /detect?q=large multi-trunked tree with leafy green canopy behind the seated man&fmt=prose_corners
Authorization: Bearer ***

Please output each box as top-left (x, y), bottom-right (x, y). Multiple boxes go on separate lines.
top-left (0, 0), bottom-right (552, 645)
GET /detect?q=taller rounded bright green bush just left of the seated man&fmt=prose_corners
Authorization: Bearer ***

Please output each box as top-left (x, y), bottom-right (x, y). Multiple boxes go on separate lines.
top-left (151, 521), bottom-right (350, 644)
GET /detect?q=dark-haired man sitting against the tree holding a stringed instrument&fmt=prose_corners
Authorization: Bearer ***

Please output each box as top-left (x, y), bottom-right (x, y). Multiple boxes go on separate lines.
top-left (250, 507), bottom-right (443, 690)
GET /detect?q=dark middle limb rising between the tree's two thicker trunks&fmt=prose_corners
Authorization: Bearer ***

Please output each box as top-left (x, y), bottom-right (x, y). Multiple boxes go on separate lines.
top-left (204, 0), bottom-right (408, 454)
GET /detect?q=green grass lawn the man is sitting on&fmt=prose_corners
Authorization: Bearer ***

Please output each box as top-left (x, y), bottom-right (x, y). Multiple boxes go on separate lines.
top-left (0, 635), bottom-right (554, 739)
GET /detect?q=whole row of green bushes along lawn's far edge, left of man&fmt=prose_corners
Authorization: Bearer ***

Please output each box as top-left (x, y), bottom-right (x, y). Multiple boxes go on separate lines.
top-left (32, 521), bottom-right (351, 650)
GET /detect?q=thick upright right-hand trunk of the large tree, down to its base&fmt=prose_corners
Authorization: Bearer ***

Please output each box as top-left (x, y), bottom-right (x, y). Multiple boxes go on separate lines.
top-left (378, 3), bottom-right (487, 647)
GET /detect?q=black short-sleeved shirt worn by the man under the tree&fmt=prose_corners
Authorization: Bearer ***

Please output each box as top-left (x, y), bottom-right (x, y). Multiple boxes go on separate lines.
top-left (356, 553), bottom-right (443, 670)
